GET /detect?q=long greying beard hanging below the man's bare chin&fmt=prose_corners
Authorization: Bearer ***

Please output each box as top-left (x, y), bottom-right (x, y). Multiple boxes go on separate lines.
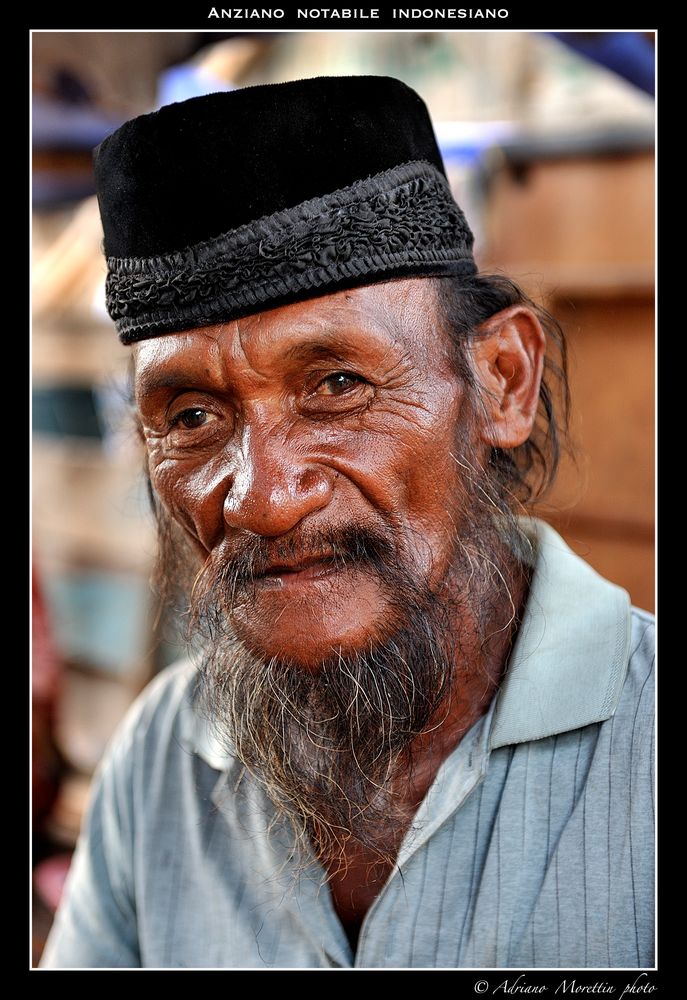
top-left (194, 544), bottom-right (454, 859)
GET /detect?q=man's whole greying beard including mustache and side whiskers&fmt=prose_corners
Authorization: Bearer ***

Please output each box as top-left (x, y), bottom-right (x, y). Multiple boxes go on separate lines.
top-left (153, 484), bottom-right (524, 864)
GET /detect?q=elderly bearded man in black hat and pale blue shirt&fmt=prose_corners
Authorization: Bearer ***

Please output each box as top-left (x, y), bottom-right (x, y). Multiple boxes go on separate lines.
top-left (42, 77), bottom-right (653, 968)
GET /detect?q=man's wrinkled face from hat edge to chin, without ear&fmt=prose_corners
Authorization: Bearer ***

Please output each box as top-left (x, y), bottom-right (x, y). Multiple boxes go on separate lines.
top-left (135, 278), bottom-right (475, 668)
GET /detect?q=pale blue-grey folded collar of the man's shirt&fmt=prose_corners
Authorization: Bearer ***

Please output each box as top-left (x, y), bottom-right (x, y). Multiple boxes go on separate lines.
top-left (187, 519), bottom-right (630, 771)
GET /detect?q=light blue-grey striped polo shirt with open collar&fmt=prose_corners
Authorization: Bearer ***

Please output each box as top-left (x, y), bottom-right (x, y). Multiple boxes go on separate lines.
top-left (41, 521), bottom-right (654, 969)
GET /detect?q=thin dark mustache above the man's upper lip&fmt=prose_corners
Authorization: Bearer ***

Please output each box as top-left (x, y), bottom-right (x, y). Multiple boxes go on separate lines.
top-left (218, 525), bottom-right (398, 589)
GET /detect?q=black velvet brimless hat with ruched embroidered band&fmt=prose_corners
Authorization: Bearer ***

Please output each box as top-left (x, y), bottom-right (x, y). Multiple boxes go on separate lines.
top-left (95, 76), bottom-right (477, 343)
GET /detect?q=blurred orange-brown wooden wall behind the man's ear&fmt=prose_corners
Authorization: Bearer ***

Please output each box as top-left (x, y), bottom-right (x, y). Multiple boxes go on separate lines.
top-left (481, 151), bottom-right (655, 610)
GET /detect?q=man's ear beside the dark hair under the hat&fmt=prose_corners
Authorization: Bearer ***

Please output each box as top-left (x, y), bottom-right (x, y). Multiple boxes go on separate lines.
top-left (470, 305), bottom-right (546, 448)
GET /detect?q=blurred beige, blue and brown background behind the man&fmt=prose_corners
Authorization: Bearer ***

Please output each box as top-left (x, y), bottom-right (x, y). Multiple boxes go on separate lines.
top-left (32, 31), bottom-right (654, 962)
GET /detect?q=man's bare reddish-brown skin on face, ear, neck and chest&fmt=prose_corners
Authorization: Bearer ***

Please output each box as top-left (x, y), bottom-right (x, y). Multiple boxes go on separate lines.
top-left (135, 279), bottom-right (544, 933)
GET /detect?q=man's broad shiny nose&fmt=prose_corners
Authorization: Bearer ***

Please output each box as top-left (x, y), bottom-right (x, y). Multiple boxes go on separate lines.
top-left (224, 425), bottom-right (336, 537)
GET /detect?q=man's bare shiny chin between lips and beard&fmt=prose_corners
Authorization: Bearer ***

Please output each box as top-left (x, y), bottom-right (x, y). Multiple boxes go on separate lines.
top-left (231, 570), bottom-right (399, 669)
